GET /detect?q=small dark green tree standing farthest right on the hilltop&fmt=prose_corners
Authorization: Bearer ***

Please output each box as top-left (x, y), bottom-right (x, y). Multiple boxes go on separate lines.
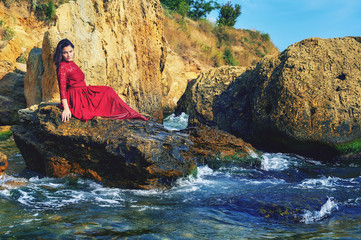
top-left (217, 1), bottom-right (241, 27)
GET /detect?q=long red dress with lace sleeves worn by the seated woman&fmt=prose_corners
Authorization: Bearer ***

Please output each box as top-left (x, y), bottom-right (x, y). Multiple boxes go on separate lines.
top-left (58, 61), bottom-right (148, 121)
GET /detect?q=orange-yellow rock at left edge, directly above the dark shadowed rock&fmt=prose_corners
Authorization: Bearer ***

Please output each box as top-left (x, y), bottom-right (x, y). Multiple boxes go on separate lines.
top-left (0, 38), bottom-right (21, 79)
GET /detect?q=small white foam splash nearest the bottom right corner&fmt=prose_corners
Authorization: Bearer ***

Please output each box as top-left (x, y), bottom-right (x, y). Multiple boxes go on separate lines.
top-left (301, 198), bottom-right (338, 223)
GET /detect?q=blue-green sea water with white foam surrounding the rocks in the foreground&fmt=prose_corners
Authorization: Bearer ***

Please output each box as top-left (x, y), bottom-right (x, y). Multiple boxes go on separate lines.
top-left (0, 115), bottom-right (361, 239)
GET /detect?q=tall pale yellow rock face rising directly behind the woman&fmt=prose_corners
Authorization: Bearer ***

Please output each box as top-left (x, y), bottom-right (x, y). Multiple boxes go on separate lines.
top-left (42, 0), bottom-right (166, 121)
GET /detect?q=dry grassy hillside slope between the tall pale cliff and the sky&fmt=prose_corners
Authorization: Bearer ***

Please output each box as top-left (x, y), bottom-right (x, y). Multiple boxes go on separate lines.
top-left (164, 9), bottom-right (278, 67)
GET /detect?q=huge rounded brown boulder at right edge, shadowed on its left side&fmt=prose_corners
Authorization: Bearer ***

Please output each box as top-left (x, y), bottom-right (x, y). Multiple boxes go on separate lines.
top-left (214, 37), bottom-right (361, 160)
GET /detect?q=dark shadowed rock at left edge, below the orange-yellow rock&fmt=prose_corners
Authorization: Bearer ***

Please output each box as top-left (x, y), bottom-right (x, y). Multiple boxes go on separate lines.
top-left (0, 72), bottom-right (26, 125)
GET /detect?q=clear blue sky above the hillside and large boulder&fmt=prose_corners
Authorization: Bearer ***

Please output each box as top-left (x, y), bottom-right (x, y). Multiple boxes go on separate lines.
top-left (208, 0), bottom-right (361, 51)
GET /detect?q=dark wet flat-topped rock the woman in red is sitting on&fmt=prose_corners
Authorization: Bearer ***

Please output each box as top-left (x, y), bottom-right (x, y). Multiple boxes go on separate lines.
top-left (12, 104), bottom-right (196, 189)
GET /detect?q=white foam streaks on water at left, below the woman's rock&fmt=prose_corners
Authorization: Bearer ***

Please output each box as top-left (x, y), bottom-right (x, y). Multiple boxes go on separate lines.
top-left (6, 177), bottom-right (129, 210)
